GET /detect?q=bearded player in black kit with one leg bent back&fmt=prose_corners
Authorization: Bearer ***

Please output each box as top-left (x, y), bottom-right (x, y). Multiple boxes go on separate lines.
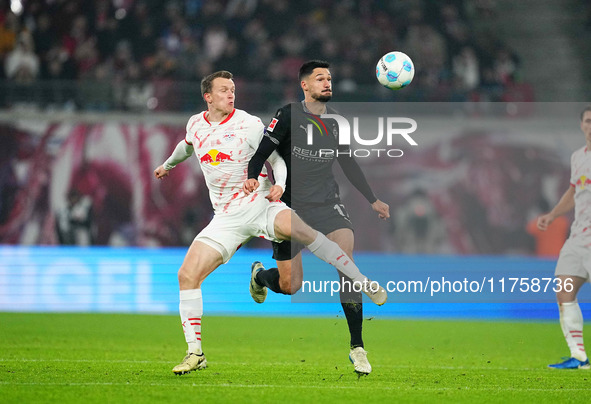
top-left (244, 60), bottom-right (390, 374)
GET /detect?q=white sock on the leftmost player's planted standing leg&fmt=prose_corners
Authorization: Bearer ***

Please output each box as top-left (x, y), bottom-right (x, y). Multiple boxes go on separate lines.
top-left (179, 289), bottom-right (203, 355)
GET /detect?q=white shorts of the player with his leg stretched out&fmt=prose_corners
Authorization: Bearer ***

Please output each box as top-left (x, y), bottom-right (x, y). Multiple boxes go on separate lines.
top-left (195, 194), bottom-right (289, 264)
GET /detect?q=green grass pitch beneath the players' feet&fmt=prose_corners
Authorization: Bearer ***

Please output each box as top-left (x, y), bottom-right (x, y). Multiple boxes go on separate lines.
top-left (0, 313), bottom-right (591, 404)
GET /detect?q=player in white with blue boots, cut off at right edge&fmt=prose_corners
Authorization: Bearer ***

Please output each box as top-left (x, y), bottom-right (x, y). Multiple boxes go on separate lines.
top-left (538, 106), bottom-right (591, 369)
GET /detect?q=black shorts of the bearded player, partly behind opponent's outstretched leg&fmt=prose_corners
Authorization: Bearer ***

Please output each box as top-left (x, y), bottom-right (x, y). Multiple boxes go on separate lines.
top-left (271, 202), bottom-right (353, 261)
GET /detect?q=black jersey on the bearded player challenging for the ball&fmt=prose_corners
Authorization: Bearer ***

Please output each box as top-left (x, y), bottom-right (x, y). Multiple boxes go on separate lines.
top-left (266, 103), bottom-right (348, 208)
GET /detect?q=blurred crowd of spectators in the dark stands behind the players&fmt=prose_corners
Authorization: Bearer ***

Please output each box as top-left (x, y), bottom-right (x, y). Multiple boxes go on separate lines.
top-left (0, 0), bottom-right (520, 110)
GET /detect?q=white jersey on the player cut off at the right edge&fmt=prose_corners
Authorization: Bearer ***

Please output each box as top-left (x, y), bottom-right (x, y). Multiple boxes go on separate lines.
top-left (570, 147), bottom-right (591, 247)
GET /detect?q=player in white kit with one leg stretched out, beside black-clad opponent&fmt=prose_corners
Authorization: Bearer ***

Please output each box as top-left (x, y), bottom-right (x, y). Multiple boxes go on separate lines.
top-left (154, 71), bottom-right (387, 374)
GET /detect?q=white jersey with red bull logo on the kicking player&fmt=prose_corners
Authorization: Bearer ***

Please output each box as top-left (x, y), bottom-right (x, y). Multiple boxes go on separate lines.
top-left (185, 109), bottom-right (271, 214)
